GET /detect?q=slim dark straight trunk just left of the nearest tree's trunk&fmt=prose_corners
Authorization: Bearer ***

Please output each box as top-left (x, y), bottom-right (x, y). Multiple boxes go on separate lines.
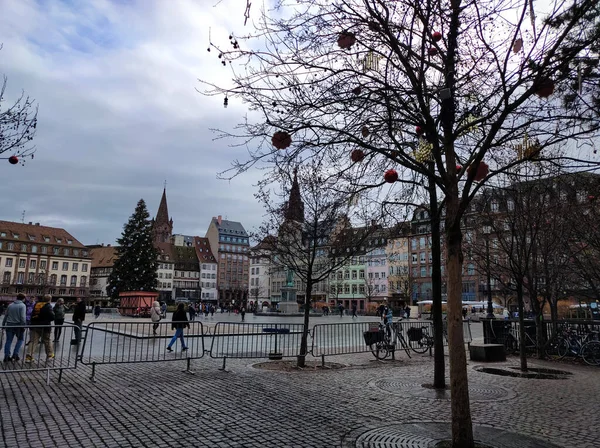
top-left (429, 170), bottom-right (446, 389)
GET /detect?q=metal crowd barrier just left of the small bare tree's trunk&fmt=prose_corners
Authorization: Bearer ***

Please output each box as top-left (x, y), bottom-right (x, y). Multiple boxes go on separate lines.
top-left (210, 322), bottom-right (310, 370)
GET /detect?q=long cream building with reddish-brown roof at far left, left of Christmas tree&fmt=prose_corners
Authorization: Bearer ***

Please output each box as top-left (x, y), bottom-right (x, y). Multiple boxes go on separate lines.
top-left (0, 221), bottom-right (92, 300)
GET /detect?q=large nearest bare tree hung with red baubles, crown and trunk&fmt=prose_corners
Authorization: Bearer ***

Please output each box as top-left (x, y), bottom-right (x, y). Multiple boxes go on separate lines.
top-left (207, 0), bottom-right (600, 448)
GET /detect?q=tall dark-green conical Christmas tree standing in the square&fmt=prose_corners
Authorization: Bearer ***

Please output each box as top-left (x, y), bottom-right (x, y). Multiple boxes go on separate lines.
top-left (108, 199), bottom-right (158, 299)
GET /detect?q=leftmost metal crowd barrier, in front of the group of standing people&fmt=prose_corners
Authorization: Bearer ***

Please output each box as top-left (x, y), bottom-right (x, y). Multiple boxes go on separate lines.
top-left (0, 323), bottom-right (80, 384)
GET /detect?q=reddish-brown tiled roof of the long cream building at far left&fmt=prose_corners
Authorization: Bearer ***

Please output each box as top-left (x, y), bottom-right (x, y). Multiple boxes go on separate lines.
top-left (0, 221), bottom-right (87, 249)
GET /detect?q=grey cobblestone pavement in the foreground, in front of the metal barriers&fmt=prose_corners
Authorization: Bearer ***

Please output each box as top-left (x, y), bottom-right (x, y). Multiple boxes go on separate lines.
top-left (0, 354), bottom-right (600, 448)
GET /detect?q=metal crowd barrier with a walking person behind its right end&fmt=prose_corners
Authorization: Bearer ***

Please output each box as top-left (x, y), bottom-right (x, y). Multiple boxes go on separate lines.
top-left (80, 321), bottom-right (205, 381)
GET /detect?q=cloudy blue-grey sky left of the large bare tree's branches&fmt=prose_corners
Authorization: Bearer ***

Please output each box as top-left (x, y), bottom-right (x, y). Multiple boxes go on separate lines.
top-left (0, 0), bottom-right (262, 244)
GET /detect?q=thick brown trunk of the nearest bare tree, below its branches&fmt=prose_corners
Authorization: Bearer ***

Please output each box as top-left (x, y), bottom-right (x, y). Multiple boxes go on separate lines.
top-left (446, 205), bottom-right (474, 448)
